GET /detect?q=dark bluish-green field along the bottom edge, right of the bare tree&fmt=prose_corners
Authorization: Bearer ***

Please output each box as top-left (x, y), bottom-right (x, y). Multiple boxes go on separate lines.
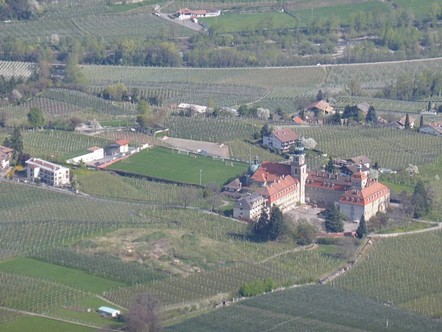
top-left (165, 285), bottom-right (440, 332)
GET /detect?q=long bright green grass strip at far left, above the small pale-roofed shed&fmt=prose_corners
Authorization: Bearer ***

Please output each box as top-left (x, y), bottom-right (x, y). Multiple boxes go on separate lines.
top-left (0, 257), bottom-right (124, 294)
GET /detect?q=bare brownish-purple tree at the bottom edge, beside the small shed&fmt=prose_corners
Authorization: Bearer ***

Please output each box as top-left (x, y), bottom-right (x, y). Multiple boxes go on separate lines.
top-left (125, 293), bottom-right (162, 332)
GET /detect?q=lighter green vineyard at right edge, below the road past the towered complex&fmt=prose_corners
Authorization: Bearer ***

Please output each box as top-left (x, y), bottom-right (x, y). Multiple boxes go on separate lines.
top-left (332, 231), bottom-right (442, 318)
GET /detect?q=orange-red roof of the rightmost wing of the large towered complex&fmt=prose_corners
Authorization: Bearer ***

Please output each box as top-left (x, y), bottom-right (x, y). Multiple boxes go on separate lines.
top-left (339, 181), bottom-right (390, 205)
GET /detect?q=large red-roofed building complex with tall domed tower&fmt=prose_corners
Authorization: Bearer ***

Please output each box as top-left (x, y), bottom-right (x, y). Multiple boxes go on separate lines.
top-left (238, 140), bottom-right (390, 220)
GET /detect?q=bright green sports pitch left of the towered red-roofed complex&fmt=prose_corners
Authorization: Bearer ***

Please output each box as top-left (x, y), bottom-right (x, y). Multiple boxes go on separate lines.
top-left (108, 148), bottom-right (247, 186)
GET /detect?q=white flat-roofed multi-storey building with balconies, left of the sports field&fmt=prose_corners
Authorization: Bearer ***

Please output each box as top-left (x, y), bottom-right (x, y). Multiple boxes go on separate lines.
top-left (26, 158), bottom-right (70, 187)
